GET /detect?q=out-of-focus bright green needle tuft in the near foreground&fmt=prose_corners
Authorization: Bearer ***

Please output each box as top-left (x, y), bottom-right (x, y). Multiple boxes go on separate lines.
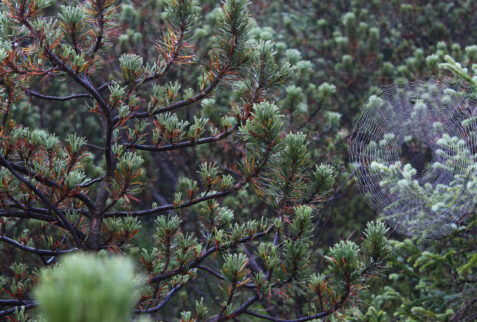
top-left (35, 254), bottom-right (141, 322)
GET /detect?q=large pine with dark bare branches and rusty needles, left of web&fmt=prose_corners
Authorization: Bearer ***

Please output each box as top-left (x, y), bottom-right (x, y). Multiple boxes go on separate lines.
top-left (0, 0), bottom-right (387, 321)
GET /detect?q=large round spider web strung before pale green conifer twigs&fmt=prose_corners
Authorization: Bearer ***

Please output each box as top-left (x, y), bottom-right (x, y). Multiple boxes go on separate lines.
top-left (349, 80), bottom-right (477, 238)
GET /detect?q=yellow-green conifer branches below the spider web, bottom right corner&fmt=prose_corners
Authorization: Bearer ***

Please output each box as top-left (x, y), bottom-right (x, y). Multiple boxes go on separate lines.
top-left (350, 215), bottom-right (475, 321)
